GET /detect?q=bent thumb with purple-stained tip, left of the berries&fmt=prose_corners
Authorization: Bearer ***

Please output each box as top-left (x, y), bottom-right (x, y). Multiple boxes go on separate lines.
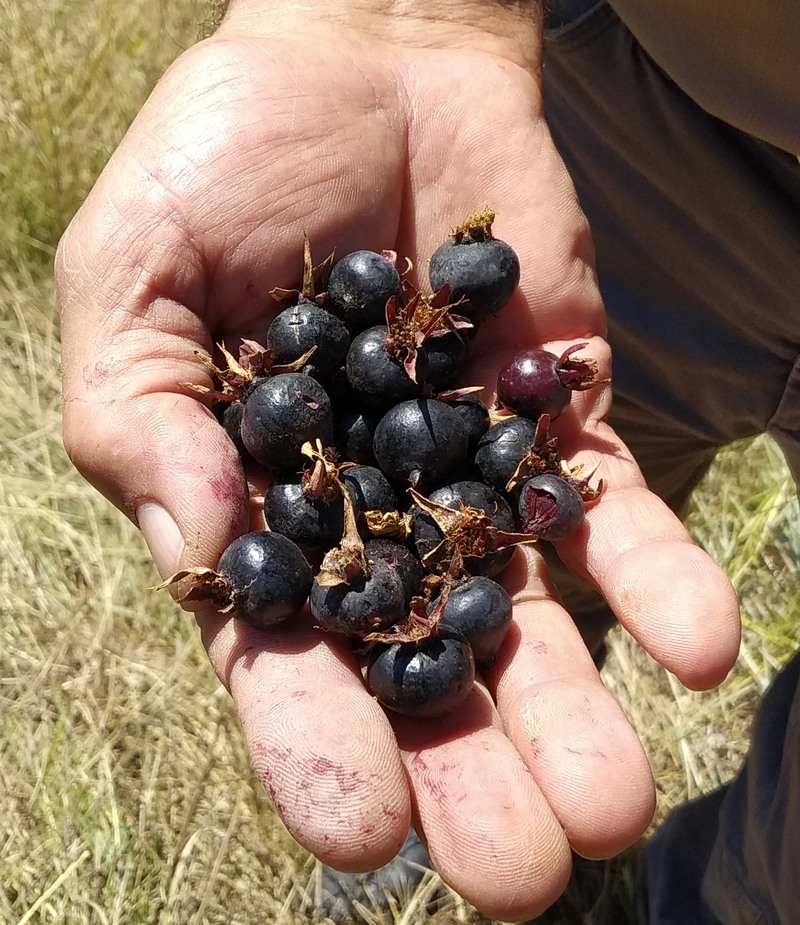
top-left (56, 240), bottom-right (248, 576)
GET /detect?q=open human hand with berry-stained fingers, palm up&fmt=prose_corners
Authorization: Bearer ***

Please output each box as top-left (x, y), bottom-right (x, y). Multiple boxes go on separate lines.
top-left (57, 0), bottom-right (738, 919)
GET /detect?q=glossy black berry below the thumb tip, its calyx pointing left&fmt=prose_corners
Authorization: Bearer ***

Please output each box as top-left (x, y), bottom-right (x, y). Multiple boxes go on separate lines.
top-left (217, 530), bottom-right (313, 628)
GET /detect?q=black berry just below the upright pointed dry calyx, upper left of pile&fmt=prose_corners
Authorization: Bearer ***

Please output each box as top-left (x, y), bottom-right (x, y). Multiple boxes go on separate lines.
top-left (267, 298), bottom-right (350, 382)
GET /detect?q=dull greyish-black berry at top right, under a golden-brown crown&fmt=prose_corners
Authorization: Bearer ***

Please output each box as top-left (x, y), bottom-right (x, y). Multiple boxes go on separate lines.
top-left (428, 235), bottom-right (520, 323)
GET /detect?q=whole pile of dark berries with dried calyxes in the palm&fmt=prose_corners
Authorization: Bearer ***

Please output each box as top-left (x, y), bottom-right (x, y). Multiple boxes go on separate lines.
top-left (168, 210), bottom-right (598, 716)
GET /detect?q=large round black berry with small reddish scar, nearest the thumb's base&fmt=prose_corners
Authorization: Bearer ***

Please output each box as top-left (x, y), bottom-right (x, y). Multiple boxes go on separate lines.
top-left (242, 373), bottom-right (333, 472)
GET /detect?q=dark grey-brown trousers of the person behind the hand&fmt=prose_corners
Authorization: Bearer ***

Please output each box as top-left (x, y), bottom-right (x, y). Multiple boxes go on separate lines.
top-left (544, 7), bottom-right (800, 925)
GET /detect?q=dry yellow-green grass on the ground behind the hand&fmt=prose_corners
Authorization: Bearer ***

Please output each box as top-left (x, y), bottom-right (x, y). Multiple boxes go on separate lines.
top-left (0, 0), bottom-right (800, 925)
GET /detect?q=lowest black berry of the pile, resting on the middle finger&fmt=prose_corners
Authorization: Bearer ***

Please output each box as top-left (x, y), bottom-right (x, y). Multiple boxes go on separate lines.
top-left (366, 627), bottom-right (475, 718)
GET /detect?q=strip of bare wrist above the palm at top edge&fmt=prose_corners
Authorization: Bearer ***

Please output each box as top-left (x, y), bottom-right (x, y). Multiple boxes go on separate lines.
top-left (221, 0), bottom-right (543, 71)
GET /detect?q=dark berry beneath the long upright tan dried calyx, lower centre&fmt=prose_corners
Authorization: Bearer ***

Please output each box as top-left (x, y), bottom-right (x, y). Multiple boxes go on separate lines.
top-left (309, 559), bottom-right (405, 636)
